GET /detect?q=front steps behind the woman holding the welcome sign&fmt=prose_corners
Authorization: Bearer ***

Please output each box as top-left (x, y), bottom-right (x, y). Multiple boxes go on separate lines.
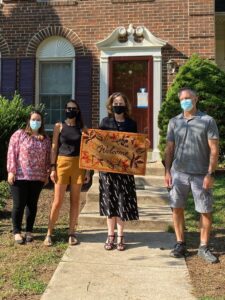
top-left (79, 161), bottom-right (172, 231)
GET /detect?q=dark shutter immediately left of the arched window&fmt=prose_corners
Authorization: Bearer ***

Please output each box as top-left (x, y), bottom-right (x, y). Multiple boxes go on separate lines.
top-left (19, 58), bottom-right (35, 104)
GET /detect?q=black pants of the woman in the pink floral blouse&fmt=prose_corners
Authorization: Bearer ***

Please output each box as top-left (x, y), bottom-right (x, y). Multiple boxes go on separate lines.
top-left (11, 180), bottom-right (44, 234)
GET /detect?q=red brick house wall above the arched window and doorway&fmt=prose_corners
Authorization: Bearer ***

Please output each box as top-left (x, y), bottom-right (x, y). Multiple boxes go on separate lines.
top-left (0, 0), bottom-right (215, 125)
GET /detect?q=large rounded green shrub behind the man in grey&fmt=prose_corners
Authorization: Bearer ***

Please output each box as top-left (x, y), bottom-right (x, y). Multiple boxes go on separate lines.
top-left (158, 54), bottom-right (225, 161)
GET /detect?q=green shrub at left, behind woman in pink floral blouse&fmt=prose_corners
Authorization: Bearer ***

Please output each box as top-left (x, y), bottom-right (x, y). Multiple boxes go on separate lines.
top-left (0, 93), bottom-right (42, 179)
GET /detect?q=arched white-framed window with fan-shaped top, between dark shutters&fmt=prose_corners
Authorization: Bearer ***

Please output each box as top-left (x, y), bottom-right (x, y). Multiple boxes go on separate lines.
top-left (36, 36), bottom-right (75, 130)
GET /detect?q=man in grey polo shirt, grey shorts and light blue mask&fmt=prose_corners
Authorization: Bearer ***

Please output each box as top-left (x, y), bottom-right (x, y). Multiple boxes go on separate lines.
top-left (165, 88), bottom-right (219, 263)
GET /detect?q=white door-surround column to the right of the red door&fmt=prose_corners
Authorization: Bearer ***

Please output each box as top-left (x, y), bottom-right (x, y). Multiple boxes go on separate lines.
top-left (152, 56), bottom-right (162, 160)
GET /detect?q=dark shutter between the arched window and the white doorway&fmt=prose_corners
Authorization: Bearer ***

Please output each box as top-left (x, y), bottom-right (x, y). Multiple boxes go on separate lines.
top-left (75, 56), bottom-right (92, 127)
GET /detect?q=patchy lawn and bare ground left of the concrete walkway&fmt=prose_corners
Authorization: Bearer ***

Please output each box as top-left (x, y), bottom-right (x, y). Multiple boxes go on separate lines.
top-left (0, 188), bottom-right (78, 300)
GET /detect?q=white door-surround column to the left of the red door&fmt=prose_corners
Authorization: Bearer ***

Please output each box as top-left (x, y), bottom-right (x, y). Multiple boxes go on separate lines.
top-left (99, 52), bottom-right (109, 121)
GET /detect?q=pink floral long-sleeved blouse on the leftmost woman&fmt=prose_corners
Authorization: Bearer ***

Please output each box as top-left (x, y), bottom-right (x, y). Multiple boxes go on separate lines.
top-left (7, 129), bottom-right (51, 181)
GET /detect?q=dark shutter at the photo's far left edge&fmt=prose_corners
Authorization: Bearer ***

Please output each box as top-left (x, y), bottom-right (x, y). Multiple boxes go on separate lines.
top-left (0, 58), bottom-right (16, 99)
